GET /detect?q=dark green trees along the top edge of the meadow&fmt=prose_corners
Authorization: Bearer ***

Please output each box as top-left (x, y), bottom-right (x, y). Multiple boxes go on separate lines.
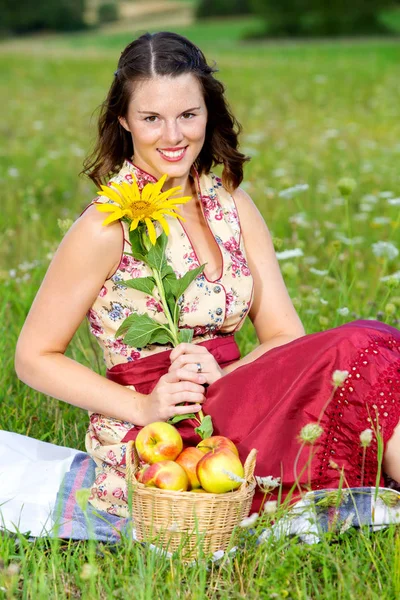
top-left (0, 0), bottom-right (400, 37)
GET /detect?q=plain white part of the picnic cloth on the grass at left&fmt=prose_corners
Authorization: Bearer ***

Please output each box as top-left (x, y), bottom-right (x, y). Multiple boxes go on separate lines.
top-left (0, 431), bottom-right (79, 537)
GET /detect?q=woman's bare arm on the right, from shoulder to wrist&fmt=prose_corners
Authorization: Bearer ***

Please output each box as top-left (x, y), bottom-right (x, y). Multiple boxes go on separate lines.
top-left (224, 188), bottom-right (305, 373)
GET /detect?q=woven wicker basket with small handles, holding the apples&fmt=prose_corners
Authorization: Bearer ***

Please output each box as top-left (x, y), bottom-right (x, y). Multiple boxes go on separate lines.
top-left (126, 442), bottom-right (257, 559)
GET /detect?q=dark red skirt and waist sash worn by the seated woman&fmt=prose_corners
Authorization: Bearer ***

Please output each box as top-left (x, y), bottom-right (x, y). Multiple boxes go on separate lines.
top-left (107, 320), bottom-right (400, 510)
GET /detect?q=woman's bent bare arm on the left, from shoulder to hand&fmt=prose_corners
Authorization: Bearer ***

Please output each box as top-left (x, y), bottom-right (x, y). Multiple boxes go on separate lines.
top-left (15, 207), bottom-right (203, 425)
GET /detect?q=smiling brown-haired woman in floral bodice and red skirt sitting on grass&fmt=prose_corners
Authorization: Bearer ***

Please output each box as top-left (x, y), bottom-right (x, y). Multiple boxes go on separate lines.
top-left (15, 33), bottom-right (400, 516)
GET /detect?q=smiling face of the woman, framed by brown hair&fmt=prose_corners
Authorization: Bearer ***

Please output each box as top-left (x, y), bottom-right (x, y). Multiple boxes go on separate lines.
top-left (120, 73), bottom-right (207, 185)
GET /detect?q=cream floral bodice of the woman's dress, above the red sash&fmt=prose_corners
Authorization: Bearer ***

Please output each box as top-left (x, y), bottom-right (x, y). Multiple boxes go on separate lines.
top-left (87, 161), bottom-right (253, 368)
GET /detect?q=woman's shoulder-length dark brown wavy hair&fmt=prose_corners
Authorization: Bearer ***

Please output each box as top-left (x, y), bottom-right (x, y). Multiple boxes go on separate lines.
top-left (81, 31), bottom-right (250, 191)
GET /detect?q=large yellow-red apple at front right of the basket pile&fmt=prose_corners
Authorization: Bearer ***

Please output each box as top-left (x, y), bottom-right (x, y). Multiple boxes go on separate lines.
top-left (197, 448), bottom-right (244, 494)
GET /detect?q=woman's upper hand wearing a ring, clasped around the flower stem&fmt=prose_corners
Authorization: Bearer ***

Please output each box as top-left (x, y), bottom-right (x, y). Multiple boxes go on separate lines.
top-left (168, 343), bottom-right (225, 385)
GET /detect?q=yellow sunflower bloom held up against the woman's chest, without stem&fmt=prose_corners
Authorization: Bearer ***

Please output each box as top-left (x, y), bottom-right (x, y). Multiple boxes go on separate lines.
top-left (96, 175), bottom-right (191, 245)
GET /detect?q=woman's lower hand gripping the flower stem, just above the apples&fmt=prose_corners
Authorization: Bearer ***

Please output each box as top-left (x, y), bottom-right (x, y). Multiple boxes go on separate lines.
top-left (145, 371), bottom-right (206, 423)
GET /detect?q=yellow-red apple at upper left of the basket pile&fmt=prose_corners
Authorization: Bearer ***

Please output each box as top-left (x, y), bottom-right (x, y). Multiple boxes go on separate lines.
top-left (135, 421), bottom-right (183, 465)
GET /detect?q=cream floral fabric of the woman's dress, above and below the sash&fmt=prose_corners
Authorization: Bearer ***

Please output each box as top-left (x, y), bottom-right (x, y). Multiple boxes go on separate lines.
top-left (86, 161), bottom-right (253, 516)
